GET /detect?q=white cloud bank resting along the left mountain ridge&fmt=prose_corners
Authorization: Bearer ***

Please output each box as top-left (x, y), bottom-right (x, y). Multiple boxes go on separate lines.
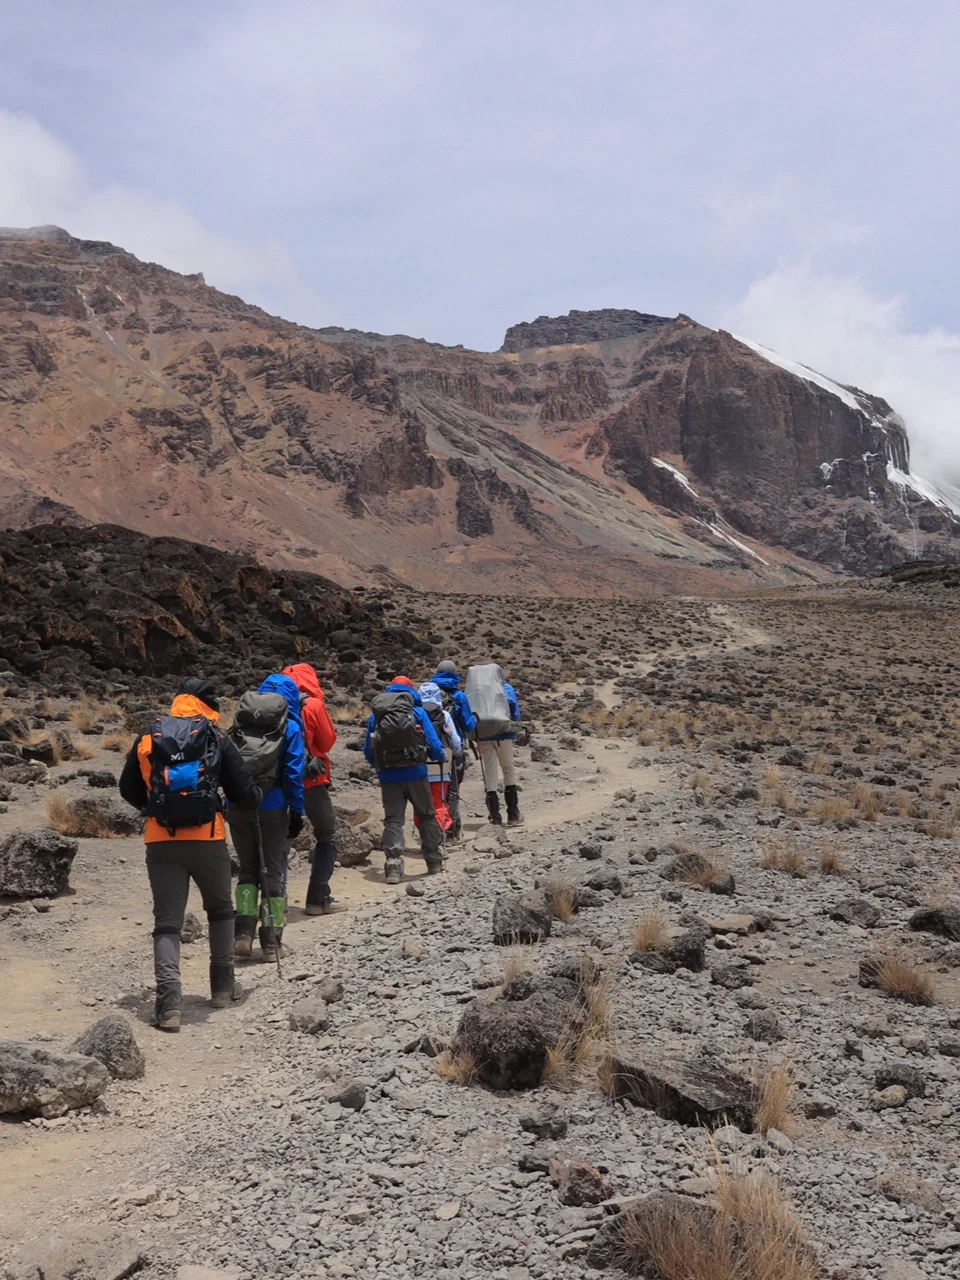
top-left (0, 110), bottom-right (315, 306)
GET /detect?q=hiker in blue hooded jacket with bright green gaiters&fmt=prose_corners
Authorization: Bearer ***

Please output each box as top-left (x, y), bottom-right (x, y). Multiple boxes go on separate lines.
top-left (227, 676), bottom-right (306, 963)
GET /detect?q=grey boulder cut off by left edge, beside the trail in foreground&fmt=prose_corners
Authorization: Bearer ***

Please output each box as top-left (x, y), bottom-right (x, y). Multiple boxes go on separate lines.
top-left (0, 1041), bottom-right (110, 1119)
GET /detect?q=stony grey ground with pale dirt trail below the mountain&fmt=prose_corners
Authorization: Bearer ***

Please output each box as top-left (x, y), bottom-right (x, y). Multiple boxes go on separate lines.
top-left (0, 582), bottom-right (960, 1280)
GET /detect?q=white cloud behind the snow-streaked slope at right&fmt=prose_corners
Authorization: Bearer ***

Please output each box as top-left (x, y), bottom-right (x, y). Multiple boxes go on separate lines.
top-left (721, 262), bottom-right (960, 483)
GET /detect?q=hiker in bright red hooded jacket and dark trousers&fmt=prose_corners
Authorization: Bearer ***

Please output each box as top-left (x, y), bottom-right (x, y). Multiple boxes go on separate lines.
top-left (283, 662), bottom-right (344, 915)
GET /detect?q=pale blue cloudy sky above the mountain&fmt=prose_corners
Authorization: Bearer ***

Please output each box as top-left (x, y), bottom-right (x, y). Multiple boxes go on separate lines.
top-left (0, 0), bottom-right (960, 480)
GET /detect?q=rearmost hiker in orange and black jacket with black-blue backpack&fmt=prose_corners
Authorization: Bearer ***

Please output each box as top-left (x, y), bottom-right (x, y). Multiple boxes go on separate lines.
top-left (119, 676), bottom-right (260, 1032)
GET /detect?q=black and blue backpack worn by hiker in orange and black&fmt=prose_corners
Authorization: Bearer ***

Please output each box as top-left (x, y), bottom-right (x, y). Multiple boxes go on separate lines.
top-left (147, 716), bottom-right (223, 837)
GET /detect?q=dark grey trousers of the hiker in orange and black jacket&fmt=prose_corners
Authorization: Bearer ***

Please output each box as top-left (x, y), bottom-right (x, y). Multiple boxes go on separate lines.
top-left (147, 840), bottom-right (233, 989)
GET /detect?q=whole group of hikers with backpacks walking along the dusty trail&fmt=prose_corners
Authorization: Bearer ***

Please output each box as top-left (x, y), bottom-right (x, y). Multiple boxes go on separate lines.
top-left (119, 660), bottom-right (524, 1032)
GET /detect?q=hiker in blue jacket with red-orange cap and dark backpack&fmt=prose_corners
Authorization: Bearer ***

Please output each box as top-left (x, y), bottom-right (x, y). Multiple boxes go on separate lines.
top-left (364, 676), bottom-right (445, 884)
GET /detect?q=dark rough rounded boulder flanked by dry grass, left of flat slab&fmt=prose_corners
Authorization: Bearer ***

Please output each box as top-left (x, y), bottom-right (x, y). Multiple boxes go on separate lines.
top-left (453, 973), bottom-right (584, 1089)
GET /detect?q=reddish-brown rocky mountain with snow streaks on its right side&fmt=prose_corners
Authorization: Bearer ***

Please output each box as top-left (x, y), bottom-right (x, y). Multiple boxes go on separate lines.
top-left (0, 228), bottom-right (960, 595)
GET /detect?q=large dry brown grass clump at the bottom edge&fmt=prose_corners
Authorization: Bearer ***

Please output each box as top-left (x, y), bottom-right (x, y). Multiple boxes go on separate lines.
top-left (618, 1161), bottom-right (820, 1280)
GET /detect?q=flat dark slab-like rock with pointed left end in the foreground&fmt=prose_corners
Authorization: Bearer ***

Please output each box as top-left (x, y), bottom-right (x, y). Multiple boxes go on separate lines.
top-left (604, 1055), bottom-right (756, 1133)
